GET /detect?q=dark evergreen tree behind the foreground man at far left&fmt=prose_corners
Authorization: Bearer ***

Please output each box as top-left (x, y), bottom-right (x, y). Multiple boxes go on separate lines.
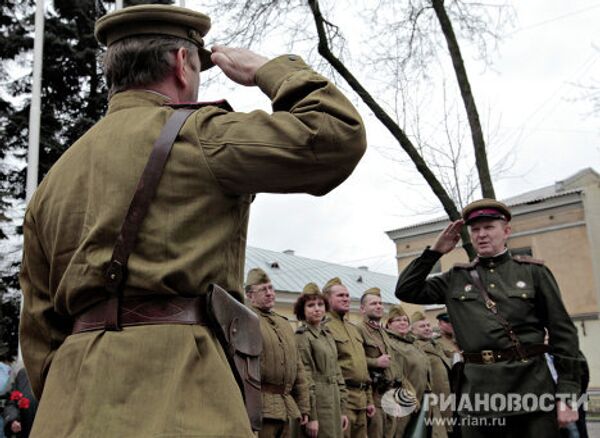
top-left (0, 0), bottom-right (172, 357)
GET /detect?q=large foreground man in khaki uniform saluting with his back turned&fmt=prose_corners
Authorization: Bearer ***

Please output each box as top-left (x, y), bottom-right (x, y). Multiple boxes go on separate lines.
top-left (20, 5), bottom-right (366, 437)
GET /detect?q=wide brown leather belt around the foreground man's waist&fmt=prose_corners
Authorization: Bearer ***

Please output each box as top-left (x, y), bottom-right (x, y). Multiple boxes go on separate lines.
top-left (73, 295), bottom-right (208, 334)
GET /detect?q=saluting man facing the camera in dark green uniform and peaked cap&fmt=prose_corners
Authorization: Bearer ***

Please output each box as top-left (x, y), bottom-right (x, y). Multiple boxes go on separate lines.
top-left (396, 199), bottom-right (580, 437)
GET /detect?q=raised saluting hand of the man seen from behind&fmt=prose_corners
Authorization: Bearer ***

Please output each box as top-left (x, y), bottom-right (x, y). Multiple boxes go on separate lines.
top-left (210, 45), bottom-right (268, 86)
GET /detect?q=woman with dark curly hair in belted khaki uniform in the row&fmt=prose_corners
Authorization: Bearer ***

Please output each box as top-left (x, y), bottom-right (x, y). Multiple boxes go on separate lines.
top-left (294, 283), bottom-right (348, 438)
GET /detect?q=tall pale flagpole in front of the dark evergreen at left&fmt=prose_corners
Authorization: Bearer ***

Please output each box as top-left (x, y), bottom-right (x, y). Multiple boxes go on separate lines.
top-left (25, 0), bottom-right (45, 202)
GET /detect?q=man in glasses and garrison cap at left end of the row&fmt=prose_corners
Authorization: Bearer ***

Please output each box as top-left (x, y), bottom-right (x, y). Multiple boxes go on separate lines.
top-left (246, 268), bottom-right (312, 438)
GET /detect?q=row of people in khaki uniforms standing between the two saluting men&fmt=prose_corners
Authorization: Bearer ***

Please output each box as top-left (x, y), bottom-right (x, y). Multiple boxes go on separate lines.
top-left (245, 268), bottom-right (458, 438)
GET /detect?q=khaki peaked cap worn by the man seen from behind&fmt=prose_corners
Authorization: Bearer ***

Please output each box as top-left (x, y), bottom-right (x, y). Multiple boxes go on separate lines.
top-left (94, 5), bottom-right (214, 71)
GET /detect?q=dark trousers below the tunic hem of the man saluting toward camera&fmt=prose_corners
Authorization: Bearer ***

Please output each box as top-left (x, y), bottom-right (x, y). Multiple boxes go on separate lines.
top-left (461, 411), bottom-right (560, 438)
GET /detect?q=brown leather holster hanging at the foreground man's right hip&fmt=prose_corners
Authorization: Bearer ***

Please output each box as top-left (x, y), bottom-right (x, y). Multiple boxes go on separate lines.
top-left (207, 284), bottom-right (262, 431)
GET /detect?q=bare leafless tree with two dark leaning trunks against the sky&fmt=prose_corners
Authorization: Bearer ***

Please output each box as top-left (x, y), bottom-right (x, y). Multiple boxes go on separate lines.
top-left (201, 0), bottom-right (512, 258)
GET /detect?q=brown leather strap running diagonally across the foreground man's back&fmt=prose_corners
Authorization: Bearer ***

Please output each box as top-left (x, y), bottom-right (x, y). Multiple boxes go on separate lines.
top-left (104, 109), bottom-right (194, 330)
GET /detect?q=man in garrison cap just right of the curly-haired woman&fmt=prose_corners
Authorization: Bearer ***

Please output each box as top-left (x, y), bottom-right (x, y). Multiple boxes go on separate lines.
top-left (323, 277), bottom-right (376, 438)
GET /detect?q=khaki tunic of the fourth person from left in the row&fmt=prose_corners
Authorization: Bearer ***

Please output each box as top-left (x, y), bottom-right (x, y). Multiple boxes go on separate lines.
top-left (358, 321), bottom-right (404, 438)
